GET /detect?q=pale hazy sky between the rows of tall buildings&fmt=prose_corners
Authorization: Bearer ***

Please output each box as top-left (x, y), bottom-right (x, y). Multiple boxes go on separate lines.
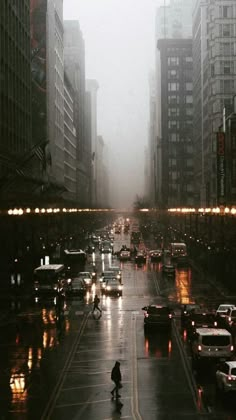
top-left (64, 0), bottom-right (168, 207)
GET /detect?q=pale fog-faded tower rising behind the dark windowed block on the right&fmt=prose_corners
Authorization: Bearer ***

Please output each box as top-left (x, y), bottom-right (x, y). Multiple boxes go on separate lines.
top-left (153, 0), bottom-right (193, 206)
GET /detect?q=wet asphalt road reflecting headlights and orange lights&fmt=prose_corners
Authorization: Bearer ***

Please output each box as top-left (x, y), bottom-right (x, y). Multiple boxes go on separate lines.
top-left (0, 231), bottom-right (236, 420)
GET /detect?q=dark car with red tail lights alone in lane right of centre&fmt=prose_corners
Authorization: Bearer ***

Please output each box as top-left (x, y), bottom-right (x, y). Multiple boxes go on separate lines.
top-left (142, 305), bottom-right (173, 330)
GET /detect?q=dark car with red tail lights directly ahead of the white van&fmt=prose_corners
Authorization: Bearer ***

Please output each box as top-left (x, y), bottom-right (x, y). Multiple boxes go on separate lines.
top-left (186, 311), bottom-right (218, 337)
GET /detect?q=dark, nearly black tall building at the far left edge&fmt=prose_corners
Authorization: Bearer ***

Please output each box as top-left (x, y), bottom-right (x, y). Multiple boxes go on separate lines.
top-left (0, 0), bottom-right (33, 205)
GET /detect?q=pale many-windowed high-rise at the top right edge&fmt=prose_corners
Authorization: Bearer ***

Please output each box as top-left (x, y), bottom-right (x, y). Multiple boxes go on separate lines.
top-left (193, 0), bottom-right (236, 206)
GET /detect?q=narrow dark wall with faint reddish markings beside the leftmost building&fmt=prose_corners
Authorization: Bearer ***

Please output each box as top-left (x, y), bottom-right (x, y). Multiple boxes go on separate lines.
top-left (30, 0), bottom-right (47, 151)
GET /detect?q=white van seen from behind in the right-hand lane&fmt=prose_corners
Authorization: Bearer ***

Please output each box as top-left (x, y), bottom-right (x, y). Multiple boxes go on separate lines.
top-left (192, 328), bottom-right (234, 361)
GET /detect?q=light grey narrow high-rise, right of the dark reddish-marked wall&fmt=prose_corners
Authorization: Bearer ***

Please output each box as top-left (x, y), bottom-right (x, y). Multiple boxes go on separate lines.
top-left (46, 0), bottom-right (64, 191)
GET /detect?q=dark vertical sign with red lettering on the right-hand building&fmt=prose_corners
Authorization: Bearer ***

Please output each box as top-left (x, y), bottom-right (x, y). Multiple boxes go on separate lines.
top-left (217, 132), bottom-right (226, 206)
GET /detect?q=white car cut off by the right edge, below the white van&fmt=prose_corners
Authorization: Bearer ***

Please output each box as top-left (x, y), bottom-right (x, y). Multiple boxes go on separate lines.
top-left (216, 360), bottom-right (236, 393)
